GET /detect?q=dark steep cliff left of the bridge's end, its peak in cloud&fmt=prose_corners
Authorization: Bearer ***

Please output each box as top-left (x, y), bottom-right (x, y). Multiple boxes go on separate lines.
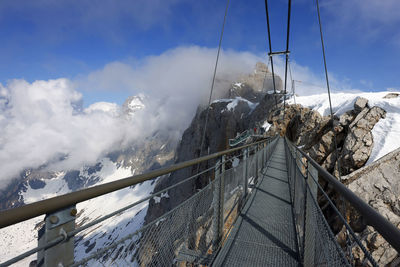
top-left (146, 63), bottom-right (275, 222)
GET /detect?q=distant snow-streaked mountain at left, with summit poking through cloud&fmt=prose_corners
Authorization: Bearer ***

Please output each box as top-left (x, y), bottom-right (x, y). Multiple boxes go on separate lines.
top-left (0, 93), bottom-right (178, 266)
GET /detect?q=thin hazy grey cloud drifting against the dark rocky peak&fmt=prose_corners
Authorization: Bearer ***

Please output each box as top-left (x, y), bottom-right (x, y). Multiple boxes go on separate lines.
top-left (76, 46), bottom-right (262, 129)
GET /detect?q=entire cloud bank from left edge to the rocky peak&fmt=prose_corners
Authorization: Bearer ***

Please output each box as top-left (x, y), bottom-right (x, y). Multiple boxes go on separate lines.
top-left (0, 47), bottom-right (260, 188)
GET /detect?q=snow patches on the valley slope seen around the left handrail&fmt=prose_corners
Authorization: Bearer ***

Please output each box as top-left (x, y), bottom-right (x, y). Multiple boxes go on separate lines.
top-left (0, 158), bottom-right (158, 266)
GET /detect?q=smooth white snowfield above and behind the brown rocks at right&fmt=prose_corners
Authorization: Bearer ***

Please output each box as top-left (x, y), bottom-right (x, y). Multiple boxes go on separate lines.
top-left (289, 91), bottom-right (400, 164)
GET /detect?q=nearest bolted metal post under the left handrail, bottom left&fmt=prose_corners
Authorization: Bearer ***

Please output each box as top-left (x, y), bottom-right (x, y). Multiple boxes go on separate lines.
top-left (37, 206), bottom-right (77, 267)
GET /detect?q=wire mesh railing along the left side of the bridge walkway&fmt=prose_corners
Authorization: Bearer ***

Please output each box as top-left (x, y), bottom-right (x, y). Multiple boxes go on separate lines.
top-left (0, 139), bottom-right (276, 266)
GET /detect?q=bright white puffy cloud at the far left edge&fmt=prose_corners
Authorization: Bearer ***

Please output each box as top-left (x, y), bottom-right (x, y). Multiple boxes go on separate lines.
top-left (0, 79), bottom-right (137, 186)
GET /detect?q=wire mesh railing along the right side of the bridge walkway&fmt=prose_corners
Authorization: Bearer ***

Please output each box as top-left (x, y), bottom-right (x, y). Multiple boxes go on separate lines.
top-left (286, 140), bottom-right (386, 266)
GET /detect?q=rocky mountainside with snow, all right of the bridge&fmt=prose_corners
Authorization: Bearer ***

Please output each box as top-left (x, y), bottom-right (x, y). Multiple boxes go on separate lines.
top-left (267, 93), bottom-right (400, 266)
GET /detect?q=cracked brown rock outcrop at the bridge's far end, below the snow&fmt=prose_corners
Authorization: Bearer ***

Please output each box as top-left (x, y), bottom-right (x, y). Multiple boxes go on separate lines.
top-left (268, 98), bottom-right (386, 177)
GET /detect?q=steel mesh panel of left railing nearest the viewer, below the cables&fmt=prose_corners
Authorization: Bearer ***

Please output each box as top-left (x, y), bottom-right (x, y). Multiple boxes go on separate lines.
top-left (74, 181), bottom-right (216, 266)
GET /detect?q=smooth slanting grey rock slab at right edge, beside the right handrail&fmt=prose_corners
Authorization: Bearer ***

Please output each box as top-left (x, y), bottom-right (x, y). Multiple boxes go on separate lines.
top-left (343, 149), bottom-right (400, 266)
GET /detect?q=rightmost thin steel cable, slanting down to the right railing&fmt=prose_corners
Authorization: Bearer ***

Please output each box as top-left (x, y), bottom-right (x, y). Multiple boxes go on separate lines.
top-left (315, 0), bottom-right (352, 256)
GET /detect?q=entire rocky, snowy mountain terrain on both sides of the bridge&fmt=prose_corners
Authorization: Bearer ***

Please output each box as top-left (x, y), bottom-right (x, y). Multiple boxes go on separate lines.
top-left (0, 59), bottom-right (400, 265)
